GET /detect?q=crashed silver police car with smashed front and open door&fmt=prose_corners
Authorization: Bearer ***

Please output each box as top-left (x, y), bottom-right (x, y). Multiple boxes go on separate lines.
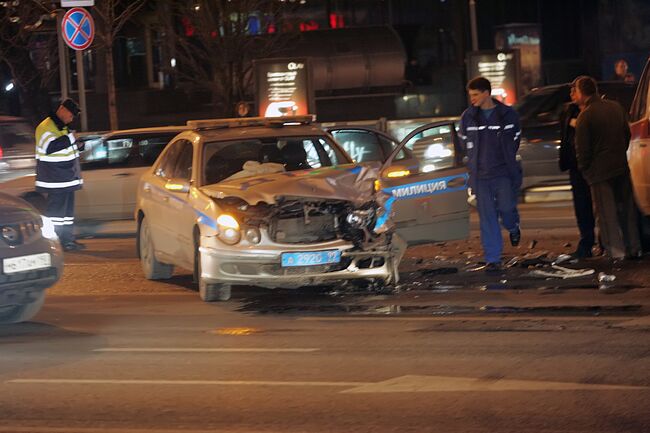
top-left (135, 116), bottom-right (469, 302)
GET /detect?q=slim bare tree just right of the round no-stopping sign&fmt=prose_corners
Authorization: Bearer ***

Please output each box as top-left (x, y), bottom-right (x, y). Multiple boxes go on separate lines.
top-left (93, 0), bottom-right (147, 130)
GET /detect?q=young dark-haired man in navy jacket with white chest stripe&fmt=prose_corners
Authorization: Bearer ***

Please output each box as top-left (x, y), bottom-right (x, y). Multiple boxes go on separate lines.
top-left (460, 77), bottom-right (522, 272)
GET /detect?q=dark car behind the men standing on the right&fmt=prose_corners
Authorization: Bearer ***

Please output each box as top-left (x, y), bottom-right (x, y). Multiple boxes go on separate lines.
top-left (514, 81), bottom-right (635, 190)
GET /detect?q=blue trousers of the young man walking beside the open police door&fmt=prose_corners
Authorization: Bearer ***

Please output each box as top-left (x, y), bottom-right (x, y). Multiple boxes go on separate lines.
top-left (476, 177), bottom-right (519, 263)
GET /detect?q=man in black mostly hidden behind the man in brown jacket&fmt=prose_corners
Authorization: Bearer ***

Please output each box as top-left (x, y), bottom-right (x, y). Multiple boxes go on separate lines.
top-left (559, 82), bottom-right (596, 258)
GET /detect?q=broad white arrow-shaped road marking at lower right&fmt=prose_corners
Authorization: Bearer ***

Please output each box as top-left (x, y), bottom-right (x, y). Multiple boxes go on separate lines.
top-left (342, 375), bottom-right (648, 394)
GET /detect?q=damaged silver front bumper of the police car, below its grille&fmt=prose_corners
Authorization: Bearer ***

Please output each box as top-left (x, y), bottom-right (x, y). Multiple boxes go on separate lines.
top-left (200, 241), bottom-right (393, 288)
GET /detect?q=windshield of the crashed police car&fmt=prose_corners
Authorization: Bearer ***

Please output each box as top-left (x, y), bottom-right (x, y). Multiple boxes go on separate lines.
top-left (201, 136), bottom-right (350, 185)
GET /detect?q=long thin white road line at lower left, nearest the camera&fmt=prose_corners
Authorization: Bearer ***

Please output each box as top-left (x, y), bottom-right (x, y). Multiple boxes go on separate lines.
top-left (6, 379), bottom-right (364, 388)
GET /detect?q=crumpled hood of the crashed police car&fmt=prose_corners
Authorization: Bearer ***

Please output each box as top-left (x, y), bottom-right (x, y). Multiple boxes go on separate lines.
top-left (201, 164), bottom-right (380, 205)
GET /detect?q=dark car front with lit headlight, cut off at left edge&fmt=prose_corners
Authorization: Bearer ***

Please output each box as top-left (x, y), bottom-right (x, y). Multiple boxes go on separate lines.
top-left (0, 193), bottom-right (63, 324)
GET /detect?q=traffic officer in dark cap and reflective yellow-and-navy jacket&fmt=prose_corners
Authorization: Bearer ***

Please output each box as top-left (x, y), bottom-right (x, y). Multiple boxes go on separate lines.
top-left (36, 98), bottom-right (85, 251)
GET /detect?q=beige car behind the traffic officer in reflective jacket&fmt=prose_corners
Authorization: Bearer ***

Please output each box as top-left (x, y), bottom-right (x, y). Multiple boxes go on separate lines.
top-left (2, 126), bottom-right (188, 223)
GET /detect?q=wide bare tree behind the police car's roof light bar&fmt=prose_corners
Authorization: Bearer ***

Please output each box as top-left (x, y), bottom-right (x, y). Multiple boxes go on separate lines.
top-left (157, 0), bottom-right (297, 115)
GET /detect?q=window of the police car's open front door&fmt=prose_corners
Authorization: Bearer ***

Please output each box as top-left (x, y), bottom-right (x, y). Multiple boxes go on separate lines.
top-left (394, 125), bottom-right (460, 173)
